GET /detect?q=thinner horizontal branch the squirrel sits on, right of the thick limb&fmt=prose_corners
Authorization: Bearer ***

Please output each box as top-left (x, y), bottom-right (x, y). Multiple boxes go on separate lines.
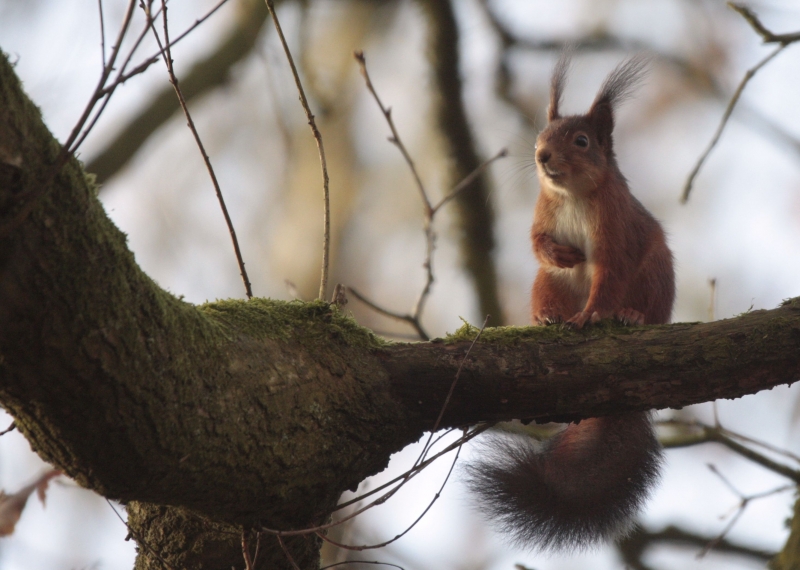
top-left (382, 299), bottom-right (800, 427)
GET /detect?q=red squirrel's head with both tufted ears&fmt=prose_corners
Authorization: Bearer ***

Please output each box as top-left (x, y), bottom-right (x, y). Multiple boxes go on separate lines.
top-left (536, 52), bottom-right (647, 196)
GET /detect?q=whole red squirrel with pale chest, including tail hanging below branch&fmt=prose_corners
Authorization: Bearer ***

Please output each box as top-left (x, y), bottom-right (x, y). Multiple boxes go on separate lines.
top-left (468, 54), bottom-right (675, 550)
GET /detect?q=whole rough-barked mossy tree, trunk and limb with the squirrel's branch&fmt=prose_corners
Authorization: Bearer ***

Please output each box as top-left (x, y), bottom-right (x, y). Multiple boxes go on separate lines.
top-left (0, 50), bottom-right (800, 569)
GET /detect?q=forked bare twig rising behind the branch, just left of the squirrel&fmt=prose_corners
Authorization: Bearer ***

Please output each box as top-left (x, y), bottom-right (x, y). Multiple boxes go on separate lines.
top-left (348, 51), bottom-right (508, 340)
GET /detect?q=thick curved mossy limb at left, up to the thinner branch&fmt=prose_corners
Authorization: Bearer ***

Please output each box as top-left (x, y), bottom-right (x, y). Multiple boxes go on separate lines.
top-left (0, 50), bottom-right (406, 568)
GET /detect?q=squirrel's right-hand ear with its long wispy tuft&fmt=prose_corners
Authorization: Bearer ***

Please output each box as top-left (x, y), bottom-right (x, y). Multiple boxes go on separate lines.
top-left (588, 54), bottom-right (650, 145)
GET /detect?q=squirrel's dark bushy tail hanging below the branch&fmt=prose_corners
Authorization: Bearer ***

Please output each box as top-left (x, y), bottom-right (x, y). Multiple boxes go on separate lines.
top-left (467, 413), bottom-right (661, 550)
